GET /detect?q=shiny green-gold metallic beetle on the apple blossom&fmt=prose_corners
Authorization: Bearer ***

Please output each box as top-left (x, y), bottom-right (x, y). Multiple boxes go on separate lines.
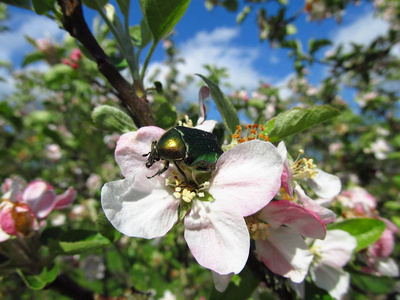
top-left (143, 126), bottom-right (223, 178)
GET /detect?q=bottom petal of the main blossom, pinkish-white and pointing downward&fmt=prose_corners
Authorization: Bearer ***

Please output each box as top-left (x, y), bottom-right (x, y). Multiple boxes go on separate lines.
top-left (184, 200), bottom-right (250, 275)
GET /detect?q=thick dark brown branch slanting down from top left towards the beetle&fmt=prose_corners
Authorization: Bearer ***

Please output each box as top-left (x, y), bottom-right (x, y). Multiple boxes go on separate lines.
top-left (58, 0), bottom-right (155, 127)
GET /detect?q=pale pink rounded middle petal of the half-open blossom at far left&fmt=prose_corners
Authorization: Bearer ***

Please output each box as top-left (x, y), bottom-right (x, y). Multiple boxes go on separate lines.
top-left (22, 180), bottom-right (56, 219)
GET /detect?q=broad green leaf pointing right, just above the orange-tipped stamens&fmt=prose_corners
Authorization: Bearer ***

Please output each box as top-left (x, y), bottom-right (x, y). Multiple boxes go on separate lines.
top-left (265, 105), bottom-right (340, 142)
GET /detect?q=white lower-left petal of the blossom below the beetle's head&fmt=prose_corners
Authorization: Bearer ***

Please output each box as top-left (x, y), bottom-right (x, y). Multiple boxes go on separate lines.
top-left (101, 173), bottom-right (180, 239)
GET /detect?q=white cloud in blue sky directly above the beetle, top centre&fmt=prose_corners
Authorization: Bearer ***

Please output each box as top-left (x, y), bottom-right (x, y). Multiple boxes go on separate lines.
top-left (148, 27), bottom-right (271, 101)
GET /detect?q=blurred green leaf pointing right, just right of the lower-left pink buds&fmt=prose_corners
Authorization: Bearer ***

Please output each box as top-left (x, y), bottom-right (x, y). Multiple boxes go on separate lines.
top-left (50, 229), bottom-right (111, 255)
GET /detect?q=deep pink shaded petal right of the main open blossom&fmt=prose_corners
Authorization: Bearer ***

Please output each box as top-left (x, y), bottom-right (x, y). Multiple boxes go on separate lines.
top-left (258, 200), bottom-right (326, 239)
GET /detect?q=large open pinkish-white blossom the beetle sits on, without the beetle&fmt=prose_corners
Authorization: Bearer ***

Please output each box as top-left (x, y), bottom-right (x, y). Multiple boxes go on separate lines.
top-left (101, 126), bottom-right (282, 274)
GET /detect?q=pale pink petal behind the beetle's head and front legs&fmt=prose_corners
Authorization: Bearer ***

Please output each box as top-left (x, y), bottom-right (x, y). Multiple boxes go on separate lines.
top-left (115, 126), bottom-right (165, 177)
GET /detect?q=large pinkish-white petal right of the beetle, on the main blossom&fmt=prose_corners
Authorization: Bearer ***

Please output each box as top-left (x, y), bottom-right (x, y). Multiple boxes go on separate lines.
top-left (209, 140), bottom-right (282, 216)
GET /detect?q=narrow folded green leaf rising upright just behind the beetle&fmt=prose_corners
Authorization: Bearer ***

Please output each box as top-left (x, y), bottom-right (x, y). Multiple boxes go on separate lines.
top-left (196, 74), bottom-right (240, 135)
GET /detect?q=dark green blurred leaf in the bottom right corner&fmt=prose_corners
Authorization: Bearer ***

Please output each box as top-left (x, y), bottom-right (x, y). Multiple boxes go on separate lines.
top-left (349, 270), bottom-right (396, 295)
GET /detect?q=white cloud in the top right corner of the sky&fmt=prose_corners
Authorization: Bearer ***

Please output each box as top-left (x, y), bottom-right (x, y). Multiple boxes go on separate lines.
top-left (331, 12), bottom-right (389, 50)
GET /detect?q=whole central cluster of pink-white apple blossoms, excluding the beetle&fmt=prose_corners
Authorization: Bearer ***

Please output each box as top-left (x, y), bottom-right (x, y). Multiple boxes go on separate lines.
top-left (101, 117), bottom-right (378, 298)
